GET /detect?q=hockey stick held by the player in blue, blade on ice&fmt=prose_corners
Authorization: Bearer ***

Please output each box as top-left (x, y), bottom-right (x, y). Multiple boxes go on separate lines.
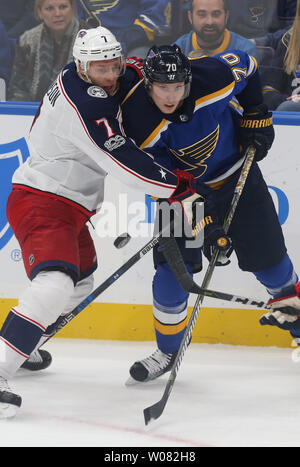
top-left (144, 146), bottom-right (255, 425)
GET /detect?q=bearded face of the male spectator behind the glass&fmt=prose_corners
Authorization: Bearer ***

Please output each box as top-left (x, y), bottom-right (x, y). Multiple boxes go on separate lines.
top-left (188, 0), bottom-right (228, 46)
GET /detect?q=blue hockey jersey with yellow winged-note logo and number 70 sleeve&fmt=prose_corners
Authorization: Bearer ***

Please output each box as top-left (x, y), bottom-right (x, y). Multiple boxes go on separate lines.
top-left (122, 50), bottom-right (262, 186)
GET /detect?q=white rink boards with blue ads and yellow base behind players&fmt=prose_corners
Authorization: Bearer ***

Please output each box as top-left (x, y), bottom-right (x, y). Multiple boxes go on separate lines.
top-left (0, 103), bottom-right (300, 347)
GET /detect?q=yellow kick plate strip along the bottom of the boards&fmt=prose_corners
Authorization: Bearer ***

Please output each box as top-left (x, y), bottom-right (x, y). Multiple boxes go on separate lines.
top-left (0, 299), bottom-right (291, 347)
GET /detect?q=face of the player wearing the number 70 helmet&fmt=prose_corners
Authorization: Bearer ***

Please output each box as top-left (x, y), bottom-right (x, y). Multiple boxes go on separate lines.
top-left (150, 81), bottom-right (185, 114)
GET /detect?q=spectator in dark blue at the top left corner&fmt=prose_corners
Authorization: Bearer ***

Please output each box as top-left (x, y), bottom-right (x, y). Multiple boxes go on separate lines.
top-left (0, 0), bottom-right (38, 40)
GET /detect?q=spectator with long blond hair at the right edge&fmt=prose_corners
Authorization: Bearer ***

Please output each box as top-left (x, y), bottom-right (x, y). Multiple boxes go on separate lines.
top-left (264, 0), bottom-right (300, 112)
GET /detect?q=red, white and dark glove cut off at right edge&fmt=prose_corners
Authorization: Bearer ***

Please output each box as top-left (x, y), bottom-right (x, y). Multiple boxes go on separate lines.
top-left (260, 282), bottom-right (300, 335)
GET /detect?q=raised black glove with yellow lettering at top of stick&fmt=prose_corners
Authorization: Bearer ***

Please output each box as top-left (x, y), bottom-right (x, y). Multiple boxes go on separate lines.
top-left (240, 104), bottom-right (275, 161)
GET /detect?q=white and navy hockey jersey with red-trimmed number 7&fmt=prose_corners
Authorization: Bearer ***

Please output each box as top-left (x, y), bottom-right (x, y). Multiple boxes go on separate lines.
top-left (13, 63), bottom-right (177, 214)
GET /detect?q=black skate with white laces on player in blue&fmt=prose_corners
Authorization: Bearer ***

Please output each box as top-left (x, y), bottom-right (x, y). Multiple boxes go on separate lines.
top-left (128, 349), bottom-right (177, 384)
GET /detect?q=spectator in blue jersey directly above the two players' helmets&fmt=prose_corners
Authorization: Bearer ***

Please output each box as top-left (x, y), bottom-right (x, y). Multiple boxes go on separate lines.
top-left (77, 0), bottom-right (172, 58)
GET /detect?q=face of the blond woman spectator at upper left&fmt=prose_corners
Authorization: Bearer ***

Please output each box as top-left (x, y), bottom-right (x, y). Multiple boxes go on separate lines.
top-left (38, 0), bottom-right (74, 33)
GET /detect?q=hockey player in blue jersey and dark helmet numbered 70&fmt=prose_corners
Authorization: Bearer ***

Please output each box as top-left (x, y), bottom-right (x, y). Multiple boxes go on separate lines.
top-left (122, 45), bottom-right (300, 381)
